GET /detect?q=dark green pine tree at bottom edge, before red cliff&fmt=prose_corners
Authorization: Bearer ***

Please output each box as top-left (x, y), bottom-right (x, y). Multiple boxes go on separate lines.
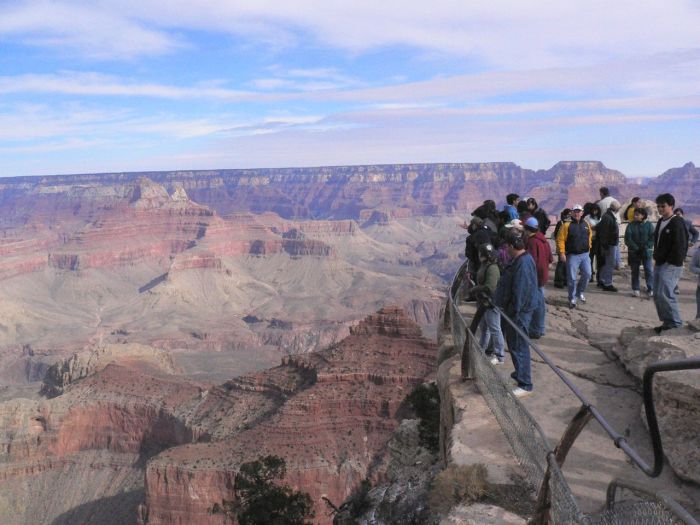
top-left (212, 456), bottom-right (314, 525)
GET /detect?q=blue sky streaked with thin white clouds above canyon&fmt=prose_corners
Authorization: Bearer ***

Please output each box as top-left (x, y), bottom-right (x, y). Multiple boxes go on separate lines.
top-left (0, 0), bottom-right (700, 177)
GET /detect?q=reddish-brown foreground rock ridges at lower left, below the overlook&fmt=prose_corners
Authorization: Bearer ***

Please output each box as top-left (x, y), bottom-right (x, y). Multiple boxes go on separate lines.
top-left (0, 308), bottom-right (435, 524)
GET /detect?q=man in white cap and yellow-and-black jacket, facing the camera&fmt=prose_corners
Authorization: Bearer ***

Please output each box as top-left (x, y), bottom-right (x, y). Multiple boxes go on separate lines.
top-left (557, 204), bottom-right (592, 308)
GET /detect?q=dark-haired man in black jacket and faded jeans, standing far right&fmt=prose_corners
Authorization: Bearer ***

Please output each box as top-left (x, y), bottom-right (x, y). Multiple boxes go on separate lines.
top-left (654, 193), bottom-right (688, 334)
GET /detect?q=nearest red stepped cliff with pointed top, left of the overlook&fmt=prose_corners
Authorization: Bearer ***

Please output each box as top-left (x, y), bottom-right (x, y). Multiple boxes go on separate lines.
top-left (141, 309), bottom-right (435, 524)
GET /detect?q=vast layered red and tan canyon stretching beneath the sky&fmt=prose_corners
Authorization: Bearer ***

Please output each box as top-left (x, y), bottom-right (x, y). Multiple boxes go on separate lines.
top-left (0, 161), bottom-right (700, 524)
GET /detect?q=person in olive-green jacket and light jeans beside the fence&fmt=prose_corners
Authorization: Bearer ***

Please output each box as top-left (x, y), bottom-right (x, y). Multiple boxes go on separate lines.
top-left (470, 244), bottom-right (506, 365)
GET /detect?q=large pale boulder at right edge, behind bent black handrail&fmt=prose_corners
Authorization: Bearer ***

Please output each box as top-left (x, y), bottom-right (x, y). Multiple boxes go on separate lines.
top-left (615, 327), bottom-right (700, 483)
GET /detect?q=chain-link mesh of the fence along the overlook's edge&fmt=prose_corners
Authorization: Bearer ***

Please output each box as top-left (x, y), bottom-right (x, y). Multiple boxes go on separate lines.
top-left (449, 262), bottom-right (697, 525)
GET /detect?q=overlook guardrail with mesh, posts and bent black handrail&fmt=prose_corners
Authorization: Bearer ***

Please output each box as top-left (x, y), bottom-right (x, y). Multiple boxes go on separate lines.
top-left (445, 261), bottom-right (700, 525)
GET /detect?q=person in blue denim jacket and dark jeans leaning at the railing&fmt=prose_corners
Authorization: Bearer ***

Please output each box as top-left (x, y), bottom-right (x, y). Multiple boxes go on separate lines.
top-left (494, 231), bottom-right (537, 397)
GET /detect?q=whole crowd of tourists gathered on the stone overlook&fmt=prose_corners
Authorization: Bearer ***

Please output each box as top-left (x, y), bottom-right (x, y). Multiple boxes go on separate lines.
top-left (463, 187), bottom-right (700, 397)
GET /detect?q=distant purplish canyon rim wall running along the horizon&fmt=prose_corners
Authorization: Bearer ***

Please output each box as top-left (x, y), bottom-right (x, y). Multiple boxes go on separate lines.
top-left (0, 161), bottom-right (700, 224)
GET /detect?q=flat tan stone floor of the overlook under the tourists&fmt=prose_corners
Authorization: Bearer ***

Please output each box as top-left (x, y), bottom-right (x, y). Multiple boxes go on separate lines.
top-left (462, 262), bottom-right (700, 513)
